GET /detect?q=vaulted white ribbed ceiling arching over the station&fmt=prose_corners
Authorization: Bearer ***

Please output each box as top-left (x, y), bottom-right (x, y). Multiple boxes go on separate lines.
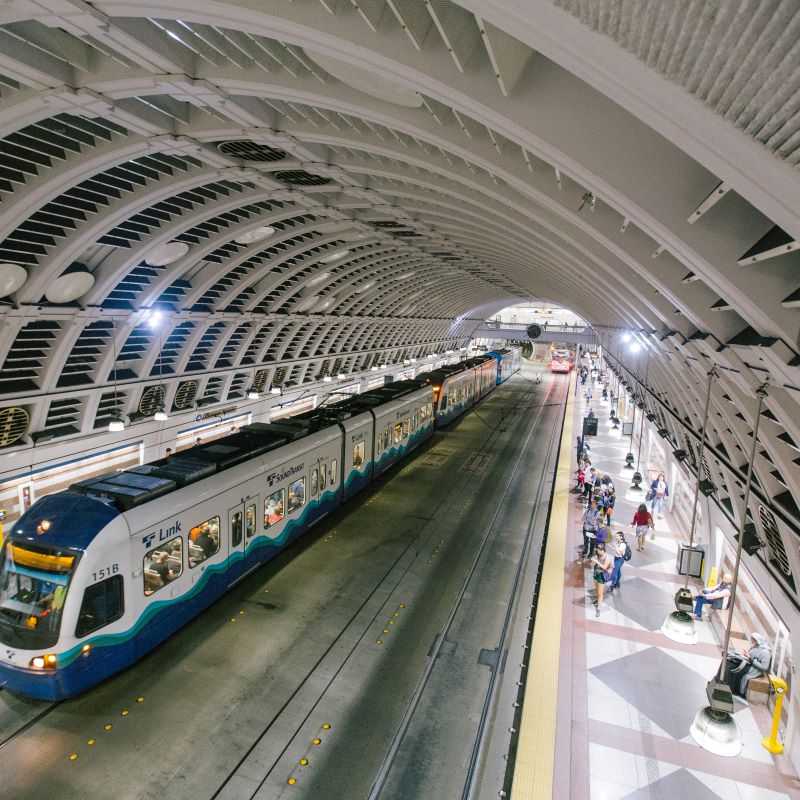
top-left (0, 0), bottom-right (800, 608)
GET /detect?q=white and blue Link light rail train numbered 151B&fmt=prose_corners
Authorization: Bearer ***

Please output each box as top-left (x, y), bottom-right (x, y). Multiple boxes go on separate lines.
top-left (0, 357), bottom-right (520, 700)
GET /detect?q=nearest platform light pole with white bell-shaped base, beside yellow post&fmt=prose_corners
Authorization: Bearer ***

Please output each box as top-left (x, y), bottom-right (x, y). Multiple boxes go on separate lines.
top-left (689, 383), bottom-right (767, 757)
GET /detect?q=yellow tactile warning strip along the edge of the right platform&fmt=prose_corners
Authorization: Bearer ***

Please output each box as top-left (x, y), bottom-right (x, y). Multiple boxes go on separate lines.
top-left (511, 392), bottom-right (575, 800)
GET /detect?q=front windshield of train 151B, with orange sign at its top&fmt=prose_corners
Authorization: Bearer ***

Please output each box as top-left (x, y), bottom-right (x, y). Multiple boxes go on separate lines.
top-left (0, 540), bottom-right (77, 649)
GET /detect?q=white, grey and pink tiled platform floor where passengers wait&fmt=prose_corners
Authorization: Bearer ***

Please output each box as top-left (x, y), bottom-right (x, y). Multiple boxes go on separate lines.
top-left (553, 378), bottom-right (800, 800)
